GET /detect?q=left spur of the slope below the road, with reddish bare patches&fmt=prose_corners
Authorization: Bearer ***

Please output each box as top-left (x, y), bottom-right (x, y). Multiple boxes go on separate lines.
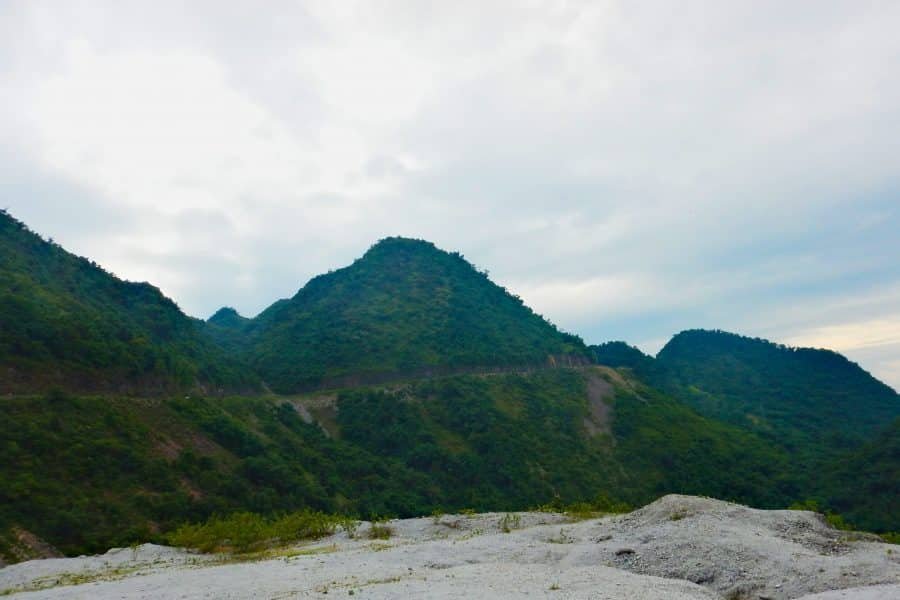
top-left (0, 394), bottom-right (430, 554)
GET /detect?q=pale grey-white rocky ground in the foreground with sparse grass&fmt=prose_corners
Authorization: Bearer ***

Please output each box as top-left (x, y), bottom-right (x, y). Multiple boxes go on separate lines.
top-left (0, 495), bottom-right (900, 600)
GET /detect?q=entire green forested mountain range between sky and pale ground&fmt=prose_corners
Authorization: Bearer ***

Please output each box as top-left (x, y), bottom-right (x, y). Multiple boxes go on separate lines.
top-left (0, 213), bottom-right (900, 560)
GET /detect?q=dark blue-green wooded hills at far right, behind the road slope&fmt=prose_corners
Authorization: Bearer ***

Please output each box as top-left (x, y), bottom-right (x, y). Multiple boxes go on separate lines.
top-left (591, 330), bottom-right (900, 531)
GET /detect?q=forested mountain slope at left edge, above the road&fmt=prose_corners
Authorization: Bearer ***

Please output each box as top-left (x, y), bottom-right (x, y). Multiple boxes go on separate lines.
top-left (0, 211), bottom-right (256, 394)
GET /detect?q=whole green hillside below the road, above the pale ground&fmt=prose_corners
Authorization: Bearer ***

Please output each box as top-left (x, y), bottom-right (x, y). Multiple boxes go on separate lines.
top-left (0, 369), bottom-right (794, 558)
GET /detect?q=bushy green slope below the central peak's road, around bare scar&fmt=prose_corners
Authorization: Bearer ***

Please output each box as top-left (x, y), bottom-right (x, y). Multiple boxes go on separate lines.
top-left (338, 370), bottom-right (795, 511)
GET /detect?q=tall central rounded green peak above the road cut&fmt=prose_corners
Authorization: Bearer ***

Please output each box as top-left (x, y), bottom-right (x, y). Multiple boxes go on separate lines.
top-left (209, 237), bottom-right (588, 393)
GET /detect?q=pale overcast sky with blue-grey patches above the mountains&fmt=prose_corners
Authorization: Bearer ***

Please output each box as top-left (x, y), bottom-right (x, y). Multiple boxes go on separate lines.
top-left (0, 0), bottom-right (900, 389)
